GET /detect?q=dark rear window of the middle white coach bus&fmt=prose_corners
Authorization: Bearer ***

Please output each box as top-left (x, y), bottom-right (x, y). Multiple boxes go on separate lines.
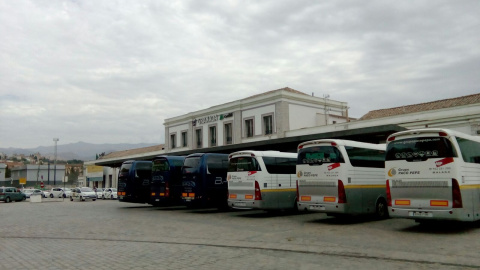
top-left (297, 146), bottom-right (345, 165)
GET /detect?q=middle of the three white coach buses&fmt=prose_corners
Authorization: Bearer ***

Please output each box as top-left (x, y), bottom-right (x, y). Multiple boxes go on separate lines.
top-left (297, 139), bottom-right (388, 218)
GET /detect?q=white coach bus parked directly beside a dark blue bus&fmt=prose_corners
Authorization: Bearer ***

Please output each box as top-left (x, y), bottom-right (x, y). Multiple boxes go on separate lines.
top-left (227, 151), bottom-right (297, 210)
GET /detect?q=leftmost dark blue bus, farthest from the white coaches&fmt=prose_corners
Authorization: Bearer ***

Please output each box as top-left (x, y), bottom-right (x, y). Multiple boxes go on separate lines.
top-left (117, 160), bottom-right (152, 203)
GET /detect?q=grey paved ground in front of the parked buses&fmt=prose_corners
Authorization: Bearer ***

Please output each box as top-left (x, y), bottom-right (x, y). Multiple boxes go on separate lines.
top-left (0, 199), bottom-right (480, 270)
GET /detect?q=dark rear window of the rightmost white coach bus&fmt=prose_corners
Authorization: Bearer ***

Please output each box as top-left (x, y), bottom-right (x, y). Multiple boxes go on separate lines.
top-left (386, 137), bottom-right (457, 161)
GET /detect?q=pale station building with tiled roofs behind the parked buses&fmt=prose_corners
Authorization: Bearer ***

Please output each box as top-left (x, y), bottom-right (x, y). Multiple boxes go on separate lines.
top-left (89, 87), bottom-right (480, 188)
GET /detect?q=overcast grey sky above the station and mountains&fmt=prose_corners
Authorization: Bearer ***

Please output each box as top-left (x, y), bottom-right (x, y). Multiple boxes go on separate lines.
top-left (0, 0), bottom-right (480, 148)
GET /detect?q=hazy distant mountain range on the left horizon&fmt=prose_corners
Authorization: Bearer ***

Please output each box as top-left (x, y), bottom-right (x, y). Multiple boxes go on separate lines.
top-left (0, 142), bottom-right (159, 161)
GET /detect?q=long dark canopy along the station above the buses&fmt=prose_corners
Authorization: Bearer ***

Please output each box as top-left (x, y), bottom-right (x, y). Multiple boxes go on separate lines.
top-left (95, 125), bottom-right (406, 167)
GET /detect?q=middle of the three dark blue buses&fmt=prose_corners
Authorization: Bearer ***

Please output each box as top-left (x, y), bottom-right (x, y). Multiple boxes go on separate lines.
top-left (150, 156), bottom-right (185, 206)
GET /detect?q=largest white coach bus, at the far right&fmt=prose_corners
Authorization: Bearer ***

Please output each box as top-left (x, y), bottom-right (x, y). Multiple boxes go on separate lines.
top-left (385, 128), bottom-right (480, 221)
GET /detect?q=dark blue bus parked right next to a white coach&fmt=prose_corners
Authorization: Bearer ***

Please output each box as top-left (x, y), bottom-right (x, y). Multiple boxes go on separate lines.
top-left (182, 153), bottom-right (228, 208)
